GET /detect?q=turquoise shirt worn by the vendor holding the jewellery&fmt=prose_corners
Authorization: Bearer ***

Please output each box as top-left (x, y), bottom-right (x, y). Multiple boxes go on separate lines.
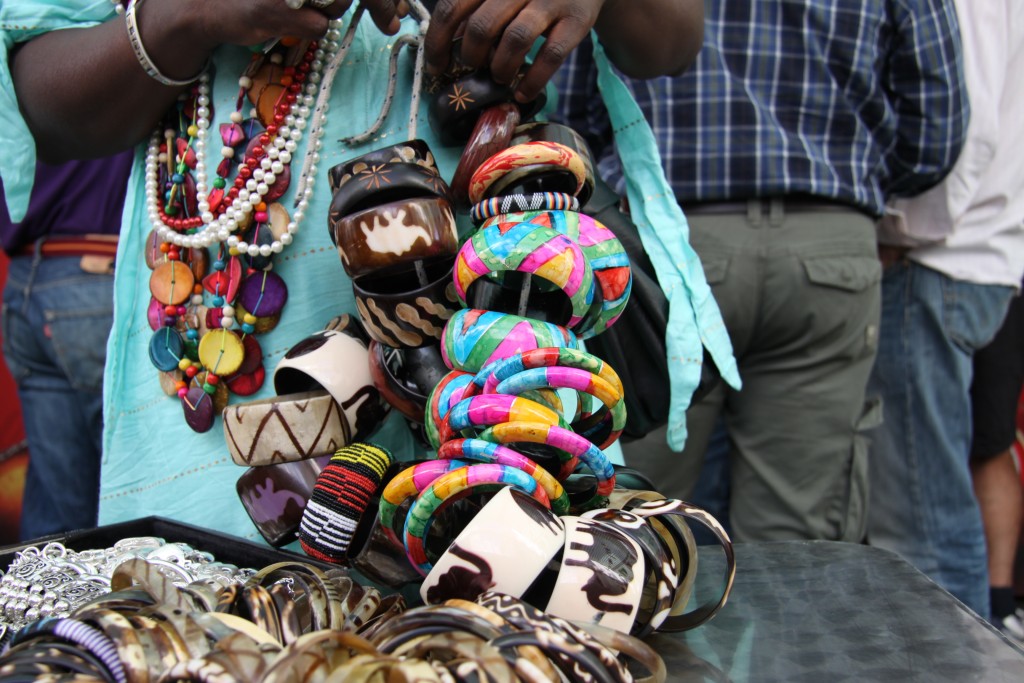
top-left (0, 0), bottom-right (735, 540)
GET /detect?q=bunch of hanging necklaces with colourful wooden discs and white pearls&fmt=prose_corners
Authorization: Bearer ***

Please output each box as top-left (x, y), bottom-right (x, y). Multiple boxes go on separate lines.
top-left (145, 28), bottom-right (340, 432)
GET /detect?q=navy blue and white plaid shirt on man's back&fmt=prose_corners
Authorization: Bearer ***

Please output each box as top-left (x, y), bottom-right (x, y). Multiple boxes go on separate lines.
top-left (552, 0), bottom-right (968, 215)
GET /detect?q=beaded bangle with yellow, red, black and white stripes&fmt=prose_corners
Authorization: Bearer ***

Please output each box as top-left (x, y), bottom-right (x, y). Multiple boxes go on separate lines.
top-left (299, 443), bottom-right (393, 562)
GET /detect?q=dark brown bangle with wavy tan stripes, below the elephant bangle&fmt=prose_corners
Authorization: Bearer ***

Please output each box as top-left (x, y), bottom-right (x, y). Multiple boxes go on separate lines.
top-left (352, 256), bottom-right (460, 348)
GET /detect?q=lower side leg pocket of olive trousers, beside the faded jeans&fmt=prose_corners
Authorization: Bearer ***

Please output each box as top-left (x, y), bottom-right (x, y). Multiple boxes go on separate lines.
top-left (825, 397), bottom-right (882, 543)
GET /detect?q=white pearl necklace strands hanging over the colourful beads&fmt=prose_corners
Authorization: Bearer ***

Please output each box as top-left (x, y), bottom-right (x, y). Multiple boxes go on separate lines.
top-left (145, 19), bottom-right (341, 257)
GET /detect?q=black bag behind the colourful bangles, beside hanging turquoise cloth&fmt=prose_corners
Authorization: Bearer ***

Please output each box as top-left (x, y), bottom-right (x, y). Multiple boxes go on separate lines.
top-left (582, 178), bottom-right (721, 441)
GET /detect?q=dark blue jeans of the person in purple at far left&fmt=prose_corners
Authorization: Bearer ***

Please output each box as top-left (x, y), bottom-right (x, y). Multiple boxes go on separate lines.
top-left (2, 250), bottom-right (114, 540)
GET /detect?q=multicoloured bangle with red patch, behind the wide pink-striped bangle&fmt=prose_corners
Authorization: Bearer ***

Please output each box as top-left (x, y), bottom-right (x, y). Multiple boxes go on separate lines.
top-left (483, 210), bottom-right (633, 339)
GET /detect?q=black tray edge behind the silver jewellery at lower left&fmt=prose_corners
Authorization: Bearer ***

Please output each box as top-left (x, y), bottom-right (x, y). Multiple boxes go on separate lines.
top-left (0, 516), bottom-right (336, 571)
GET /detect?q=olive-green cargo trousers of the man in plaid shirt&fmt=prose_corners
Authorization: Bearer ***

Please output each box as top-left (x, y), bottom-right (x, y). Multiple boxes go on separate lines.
top-left (623, 200), bottom-right (882, 542)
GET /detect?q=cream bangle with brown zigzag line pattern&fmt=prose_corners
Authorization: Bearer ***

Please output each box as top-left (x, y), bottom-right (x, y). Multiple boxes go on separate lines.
top-left (223, 390), bottom-right (351, 467)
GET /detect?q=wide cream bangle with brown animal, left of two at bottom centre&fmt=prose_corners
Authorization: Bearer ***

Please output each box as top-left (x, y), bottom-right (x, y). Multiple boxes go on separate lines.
top-left (420, 486), bottom-right (565, 604)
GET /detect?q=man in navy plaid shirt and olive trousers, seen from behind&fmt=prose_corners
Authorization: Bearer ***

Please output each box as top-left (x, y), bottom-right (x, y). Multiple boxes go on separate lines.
top-left (555, 0), bottom-right (968, 542)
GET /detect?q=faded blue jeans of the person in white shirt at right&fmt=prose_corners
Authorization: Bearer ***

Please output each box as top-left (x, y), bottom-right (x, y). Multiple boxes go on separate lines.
top-left (868, 263), bottom-right (1014, 617)
